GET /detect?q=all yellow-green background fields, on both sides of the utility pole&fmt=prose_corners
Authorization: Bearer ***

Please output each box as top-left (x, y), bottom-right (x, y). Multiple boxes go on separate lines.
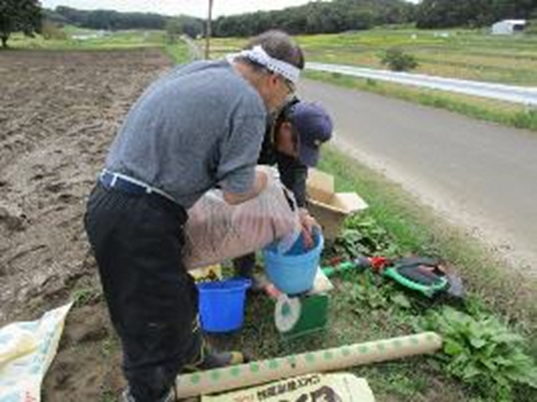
top-left (9, 26), bottom-right (537, 86)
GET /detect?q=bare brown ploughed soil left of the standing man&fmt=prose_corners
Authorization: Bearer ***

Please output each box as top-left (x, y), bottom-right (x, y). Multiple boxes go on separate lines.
top-left (0, 50), bottom-right (170, 402)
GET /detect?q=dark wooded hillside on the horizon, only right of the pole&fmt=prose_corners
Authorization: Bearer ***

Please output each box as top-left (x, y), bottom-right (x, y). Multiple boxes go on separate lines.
top-left (214, 0), bottom-right (537, 36)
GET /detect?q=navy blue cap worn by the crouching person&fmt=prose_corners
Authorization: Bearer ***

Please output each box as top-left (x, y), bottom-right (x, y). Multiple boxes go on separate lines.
top-left (289, 101), bottom-right (333, 167)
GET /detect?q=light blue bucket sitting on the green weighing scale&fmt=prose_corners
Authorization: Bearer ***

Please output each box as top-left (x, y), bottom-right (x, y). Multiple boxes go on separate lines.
top-left (263, 231), bottom-right (324, 295)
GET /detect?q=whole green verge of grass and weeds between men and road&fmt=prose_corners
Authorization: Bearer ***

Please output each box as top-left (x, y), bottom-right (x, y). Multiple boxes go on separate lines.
top-left (209, 147), bottom-right (537, 402)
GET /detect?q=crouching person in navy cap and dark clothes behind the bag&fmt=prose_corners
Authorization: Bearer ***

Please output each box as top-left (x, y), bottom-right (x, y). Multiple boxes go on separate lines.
top-left (233, 98), bottom-right (333, 291)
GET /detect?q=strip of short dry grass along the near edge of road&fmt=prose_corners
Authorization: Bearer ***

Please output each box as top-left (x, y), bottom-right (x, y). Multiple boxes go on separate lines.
top-left (314, 147), bottom-right (537, 333)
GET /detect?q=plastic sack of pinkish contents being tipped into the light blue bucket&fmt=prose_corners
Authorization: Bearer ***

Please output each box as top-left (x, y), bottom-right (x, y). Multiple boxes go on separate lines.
top-left (184, 166), bottom-right (300, 269)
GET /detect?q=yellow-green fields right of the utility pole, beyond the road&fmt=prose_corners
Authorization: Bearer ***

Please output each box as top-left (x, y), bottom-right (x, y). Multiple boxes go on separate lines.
top-left (206, 28), bottom-right (537, 86)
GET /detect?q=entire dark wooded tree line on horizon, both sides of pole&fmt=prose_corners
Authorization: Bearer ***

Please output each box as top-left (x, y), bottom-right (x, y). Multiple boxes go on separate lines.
top-left (32, 0), bottom-right (537, 37)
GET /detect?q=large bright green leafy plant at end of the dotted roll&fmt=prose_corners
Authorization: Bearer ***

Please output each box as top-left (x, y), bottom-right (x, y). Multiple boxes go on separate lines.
top-left (422, 307), bottom-right (537, 401)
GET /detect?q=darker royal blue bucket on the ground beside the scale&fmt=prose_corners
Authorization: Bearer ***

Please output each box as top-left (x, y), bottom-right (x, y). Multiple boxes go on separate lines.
top-left (197, 279), bottom-right (251, 332)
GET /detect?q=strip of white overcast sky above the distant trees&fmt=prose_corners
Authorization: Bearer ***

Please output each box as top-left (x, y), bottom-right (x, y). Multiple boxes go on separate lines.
top-left (41, 0), bottom-right (326, 17)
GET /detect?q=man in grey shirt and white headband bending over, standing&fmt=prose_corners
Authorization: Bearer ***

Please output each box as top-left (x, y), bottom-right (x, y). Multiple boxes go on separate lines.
top-left (85, 31), bottom-right (304, 402)
